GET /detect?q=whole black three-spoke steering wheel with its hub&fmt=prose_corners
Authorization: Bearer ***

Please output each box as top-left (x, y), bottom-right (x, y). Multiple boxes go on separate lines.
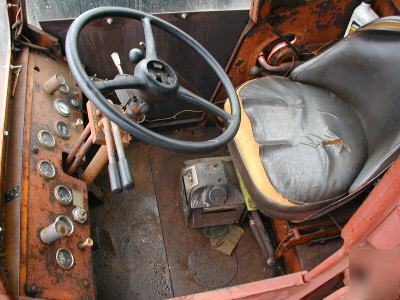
top-left (65, 7), bottom-right (240, 153)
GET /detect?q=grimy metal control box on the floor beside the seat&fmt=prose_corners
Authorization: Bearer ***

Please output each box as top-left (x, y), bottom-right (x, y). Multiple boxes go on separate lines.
top-left (180, 157), bottom-right (245, 228)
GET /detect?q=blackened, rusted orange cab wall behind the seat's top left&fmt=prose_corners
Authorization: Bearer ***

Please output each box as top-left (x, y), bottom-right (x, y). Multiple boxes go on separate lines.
top-left (213, 0), bottom-right (359, 102)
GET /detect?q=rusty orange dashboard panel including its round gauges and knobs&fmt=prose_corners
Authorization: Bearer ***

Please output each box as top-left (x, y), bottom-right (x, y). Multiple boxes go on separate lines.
top-left (5, 49), bottom-right (95, 299)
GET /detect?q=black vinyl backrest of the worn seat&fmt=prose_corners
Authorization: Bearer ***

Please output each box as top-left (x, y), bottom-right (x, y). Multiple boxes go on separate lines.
top-left (291, 17), bottom-right (400, 193)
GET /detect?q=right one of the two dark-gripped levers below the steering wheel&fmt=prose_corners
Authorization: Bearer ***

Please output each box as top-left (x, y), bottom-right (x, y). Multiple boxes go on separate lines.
top-left (111, 122), bottom-right (134, 190)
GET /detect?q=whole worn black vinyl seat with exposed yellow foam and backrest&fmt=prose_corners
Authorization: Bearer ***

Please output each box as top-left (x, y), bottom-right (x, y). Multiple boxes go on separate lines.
top-left (225, 17), bottom-right (400, 222)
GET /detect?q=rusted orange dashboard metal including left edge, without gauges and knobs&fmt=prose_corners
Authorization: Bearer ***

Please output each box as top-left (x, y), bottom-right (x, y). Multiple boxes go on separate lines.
top-left (6, 50), bottom-right (95, 299)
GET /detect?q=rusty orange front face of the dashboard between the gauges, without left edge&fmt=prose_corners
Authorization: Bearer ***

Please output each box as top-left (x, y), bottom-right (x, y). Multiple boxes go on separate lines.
top-left (19, 52), bottom-right (95, 299)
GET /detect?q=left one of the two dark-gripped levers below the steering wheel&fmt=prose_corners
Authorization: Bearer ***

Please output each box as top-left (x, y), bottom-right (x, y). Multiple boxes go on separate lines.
top-left (99, 118), bottom-right (122, 194)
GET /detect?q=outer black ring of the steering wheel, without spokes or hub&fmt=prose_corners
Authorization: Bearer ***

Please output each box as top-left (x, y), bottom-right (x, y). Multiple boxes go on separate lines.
top-left (65, 7), bottom-right (240, 153)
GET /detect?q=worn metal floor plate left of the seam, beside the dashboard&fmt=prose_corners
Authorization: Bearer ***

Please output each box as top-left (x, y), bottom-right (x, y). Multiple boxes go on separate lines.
top-left (90, 144), bottom-right (172, 299)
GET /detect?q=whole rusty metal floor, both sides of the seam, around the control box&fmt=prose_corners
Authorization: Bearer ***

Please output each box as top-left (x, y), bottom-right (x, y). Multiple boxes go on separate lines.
top-left (90, 129), bottom-right (266, 299)
